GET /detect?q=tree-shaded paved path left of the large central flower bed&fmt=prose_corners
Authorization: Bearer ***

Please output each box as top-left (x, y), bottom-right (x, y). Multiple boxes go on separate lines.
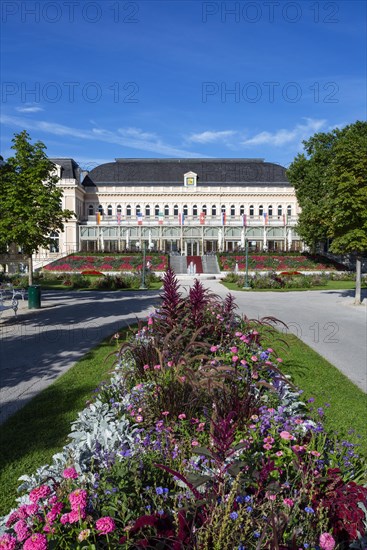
top-left (0, 291), bottom-right (159, 424)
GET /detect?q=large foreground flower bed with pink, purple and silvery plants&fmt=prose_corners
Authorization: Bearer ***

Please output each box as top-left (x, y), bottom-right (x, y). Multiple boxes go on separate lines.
top-left (0, 271), bottom-right (367, 550)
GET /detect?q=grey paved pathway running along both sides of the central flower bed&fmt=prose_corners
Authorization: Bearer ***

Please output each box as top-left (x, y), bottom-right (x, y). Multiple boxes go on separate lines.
top-left (0, 277), bottom-right (367, 423)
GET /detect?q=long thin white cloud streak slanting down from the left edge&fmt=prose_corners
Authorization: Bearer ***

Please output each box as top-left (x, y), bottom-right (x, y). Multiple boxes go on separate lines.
top-left (0, 115), bottom-right (205, 158)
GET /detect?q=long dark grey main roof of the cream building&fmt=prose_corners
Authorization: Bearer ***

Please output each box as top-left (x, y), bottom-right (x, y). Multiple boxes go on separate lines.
top-left (83, 159), bottom-right (290, 186)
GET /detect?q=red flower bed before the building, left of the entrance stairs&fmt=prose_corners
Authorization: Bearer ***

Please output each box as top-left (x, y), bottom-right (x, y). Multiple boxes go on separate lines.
top-left (44, 254), bottom-right (168, 273)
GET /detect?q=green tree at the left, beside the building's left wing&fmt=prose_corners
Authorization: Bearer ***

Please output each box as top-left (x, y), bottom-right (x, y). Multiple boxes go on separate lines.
top-left (0, 130), bottom-right (74, 284)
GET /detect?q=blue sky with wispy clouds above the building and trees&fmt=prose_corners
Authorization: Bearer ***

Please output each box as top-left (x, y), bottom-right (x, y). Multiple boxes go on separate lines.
top-left (0, 0), bottom-right (366, 168)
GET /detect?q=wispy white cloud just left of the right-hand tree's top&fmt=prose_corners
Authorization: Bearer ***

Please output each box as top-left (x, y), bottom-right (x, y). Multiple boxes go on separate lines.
top-left (241, 118), bottom-right (326, 147)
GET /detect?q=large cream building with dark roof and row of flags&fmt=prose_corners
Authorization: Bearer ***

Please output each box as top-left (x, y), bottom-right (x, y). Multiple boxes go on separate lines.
top-left (39, 158), bottom-right (302, 264)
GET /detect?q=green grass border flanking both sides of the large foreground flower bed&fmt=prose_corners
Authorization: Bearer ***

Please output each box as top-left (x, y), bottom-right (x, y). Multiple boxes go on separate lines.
top-left (0, 324), bottom-right (367, 515)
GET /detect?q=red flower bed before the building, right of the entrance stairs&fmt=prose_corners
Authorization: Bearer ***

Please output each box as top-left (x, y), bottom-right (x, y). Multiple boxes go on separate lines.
top-left (219, 254), bottom-right (336, 271)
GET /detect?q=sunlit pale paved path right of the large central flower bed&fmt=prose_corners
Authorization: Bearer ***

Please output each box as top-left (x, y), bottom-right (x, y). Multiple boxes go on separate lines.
top-left (179, 277), bottom-right (367, 394)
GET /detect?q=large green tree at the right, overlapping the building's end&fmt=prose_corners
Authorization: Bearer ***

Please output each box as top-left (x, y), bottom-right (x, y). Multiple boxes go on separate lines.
top-left (287, 121), bottom-right (367, 304)
